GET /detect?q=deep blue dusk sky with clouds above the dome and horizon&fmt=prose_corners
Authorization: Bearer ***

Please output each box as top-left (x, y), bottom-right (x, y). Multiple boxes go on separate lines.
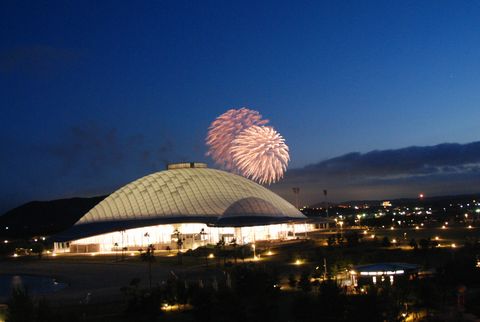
top-left (0, 0), bottom-right (480, 213)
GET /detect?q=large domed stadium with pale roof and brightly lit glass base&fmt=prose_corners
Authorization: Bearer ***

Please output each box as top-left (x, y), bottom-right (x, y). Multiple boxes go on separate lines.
top-left (55, 163), bottom-right (315, 253)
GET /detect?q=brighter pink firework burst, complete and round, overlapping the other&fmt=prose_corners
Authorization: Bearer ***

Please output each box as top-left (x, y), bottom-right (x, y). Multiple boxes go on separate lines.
top-left (231, 125), bottom-right (290, 184)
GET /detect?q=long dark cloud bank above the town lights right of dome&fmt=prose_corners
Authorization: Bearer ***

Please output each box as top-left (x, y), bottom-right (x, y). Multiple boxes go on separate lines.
top-left (272, 142), bottom-right (480, 204)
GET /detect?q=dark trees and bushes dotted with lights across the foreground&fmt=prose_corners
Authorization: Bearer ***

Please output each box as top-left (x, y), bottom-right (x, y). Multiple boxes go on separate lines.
top-left (3, 236), bottom-right (480, 322)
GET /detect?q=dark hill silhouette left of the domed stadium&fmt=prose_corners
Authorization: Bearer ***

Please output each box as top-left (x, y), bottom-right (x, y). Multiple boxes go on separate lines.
top-left (0, 196), bottom-right (106, 238)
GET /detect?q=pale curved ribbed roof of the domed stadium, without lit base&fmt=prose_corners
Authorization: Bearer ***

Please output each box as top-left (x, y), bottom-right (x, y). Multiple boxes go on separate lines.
top-left (75, 168), bottom-right (306, 225)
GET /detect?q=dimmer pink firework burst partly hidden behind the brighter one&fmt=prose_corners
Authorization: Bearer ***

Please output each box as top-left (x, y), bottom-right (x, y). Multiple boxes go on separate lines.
top-left (206, 107), bottom-right (268, 170)
